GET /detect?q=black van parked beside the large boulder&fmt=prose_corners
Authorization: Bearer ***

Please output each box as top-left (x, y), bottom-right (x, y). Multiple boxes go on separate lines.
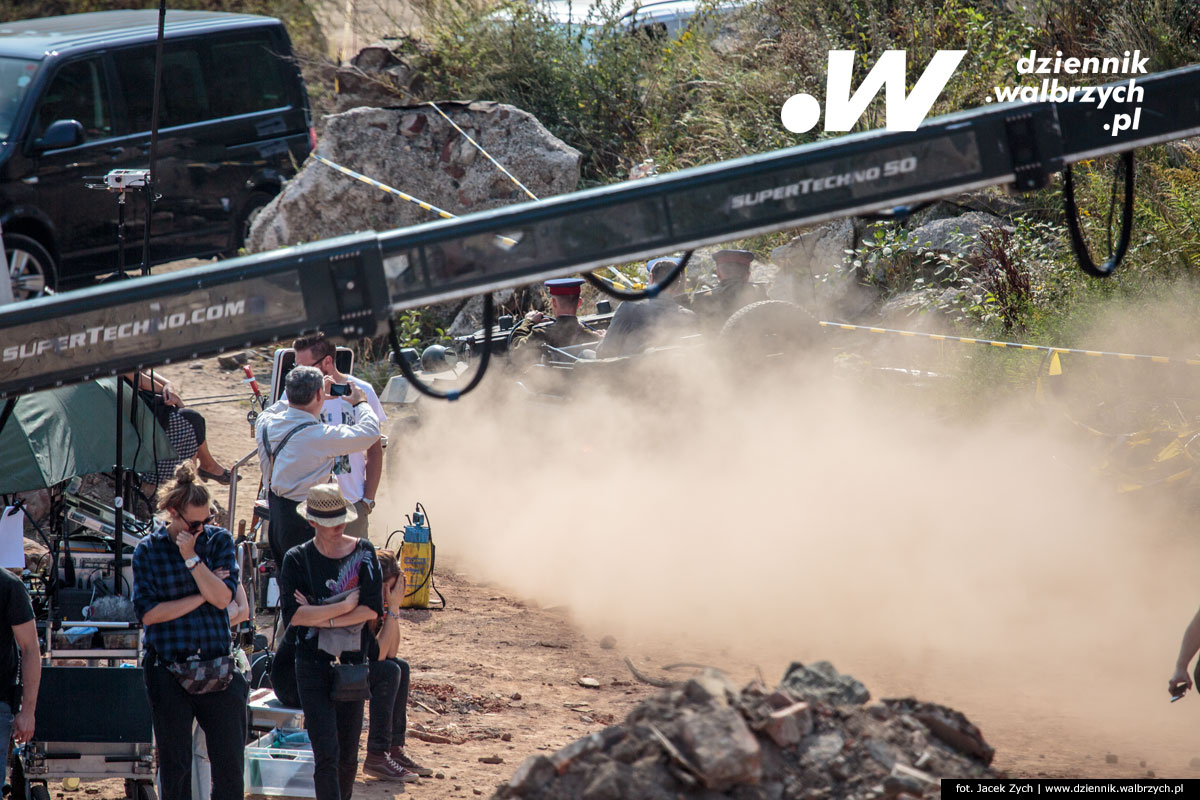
top-left (0, 8), bottom-right (316, 300)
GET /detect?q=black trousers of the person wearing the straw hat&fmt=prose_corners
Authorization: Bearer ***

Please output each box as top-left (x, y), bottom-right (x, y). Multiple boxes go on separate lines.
top-left (294, 649), bottom-right (364, 800)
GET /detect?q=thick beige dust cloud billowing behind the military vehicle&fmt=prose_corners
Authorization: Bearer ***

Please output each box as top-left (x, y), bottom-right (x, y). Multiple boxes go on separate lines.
top-left (386, 296), bottom-right (1200, 776)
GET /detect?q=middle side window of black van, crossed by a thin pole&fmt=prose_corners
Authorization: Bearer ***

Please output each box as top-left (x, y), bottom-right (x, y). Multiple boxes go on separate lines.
top-left (113, 43), bottom-right (212, 133)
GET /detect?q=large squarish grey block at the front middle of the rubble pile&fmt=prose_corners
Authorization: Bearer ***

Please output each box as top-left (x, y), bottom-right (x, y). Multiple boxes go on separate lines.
top-left (679, 708), bottom-right (762, 792)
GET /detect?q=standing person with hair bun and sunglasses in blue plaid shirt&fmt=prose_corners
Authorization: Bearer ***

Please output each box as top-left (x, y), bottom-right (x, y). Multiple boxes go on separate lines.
top-left (133, 462), bottom-right (247, 800)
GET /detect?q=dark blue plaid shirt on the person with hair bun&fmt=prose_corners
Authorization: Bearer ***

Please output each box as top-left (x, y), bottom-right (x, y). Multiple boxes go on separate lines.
top-left (133, 523), bottom-right (239, 661)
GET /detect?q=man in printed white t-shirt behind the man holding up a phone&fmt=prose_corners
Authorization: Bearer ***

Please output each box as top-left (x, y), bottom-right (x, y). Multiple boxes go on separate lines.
top-left (292, 333), bottom-right (388, 539)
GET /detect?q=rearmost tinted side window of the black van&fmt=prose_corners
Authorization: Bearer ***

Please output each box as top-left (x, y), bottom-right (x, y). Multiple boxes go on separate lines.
top-left (209, 37), bottom-right (289, 116)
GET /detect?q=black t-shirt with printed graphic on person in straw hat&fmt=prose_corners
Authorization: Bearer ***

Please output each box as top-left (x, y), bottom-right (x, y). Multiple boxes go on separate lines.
top-left (280, 539), bottom-right (383, 658)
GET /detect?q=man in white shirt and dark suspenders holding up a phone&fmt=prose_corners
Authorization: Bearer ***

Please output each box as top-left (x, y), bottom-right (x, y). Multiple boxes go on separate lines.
top-left (254, 367), bottom-right (379, 564)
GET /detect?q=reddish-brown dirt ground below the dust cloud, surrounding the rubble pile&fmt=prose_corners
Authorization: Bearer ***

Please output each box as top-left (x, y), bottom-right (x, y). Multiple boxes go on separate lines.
top-left (117, 349), bottom-right (1195, 799)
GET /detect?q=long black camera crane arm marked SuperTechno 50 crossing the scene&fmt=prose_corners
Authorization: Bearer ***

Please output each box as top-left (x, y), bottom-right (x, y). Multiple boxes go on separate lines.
top-left (0, 65), bottom-right (1200, 398)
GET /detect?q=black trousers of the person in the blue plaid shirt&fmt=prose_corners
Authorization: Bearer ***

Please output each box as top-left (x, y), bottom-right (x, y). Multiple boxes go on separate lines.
top-left (143, 658), bottom-right (248, 800)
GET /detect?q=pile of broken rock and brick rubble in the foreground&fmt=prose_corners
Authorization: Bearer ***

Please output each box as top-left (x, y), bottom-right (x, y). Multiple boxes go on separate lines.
top-left (493, 662), bottom-right (996, 800)
